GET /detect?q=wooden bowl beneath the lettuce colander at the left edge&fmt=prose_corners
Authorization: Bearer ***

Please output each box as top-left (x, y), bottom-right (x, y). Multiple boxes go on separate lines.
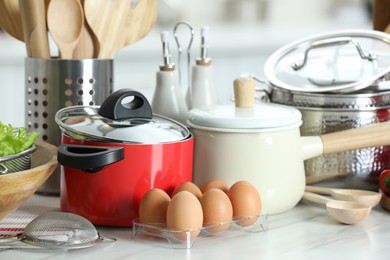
top-left (0, 141), bottom-right (58, 220)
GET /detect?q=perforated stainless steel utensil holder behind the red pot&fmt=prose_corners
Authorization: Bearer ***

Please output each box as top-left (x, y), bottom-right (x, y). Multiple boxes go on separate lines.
top-left (25, 58), bottom-right (113, 194)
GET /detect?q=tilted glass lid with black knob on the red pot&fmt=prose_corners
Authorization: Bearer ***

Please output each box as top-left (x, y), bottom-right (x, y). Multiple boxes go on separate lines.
top-left (55, 89), bottom-right (190, 144)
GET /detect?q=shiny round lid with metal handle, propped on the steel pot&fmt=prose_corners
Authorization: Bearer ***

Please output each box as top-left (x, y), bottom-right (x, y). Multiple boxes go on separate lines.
top-left (264, 30), bottom-right (390, 93)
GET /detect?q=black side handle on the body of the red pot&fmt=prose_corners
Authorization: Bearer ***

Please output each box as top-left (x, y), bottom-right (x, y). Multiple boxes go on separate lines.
top-left (57, 144), bottom-right (124, 173)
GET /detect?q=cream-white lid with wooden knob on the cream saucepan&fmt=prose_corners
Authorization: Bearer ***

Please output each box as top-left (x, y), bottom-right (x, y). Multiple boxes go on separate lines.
top-left (189, 78), bottom-right (302, 132)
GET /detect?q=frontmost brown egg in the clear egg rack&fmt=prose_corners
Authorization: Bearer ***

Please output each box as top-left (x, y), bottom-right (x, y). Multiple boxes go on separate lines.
top-left (167, 191), bottom-right (203, 240)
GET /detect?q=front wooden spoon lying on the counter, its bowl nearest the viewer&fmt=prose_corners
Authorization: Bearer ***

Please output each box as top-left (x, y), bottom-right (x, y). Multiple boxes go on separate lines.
top-left (303, 192), bottom-right (371, 224)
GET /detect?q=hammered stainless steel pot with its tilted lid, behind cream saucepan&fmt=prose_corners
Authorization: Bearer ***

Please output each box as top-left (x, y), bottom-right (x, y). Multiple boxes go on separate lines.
top-left (258, 30), bottom-right (390, 189)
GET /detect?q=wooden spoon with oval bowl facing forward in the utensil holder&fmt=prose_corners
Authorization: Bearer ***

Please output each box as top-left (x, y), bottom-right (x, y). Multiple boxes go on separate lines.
top-left (47, 0), bottom-right (84, 59)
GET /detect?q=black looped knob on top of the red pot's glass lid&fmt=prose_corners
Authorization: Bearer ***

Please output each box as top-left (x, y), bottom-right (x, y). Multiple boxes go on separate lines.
top-left (98, 88), bottom-right (153, 120)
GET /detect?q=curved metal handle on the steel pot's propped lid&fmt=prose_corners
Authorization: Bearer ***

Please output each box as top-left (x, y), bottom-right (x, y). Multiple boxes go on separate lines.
top-left (291, 37), bottom-right (376, 70)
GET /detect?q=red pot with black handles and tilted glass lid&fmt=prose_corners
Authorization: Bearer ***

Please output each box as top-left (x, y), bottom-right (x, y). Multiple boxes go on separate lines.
top-left (55, 89), bottom-right (193, 226)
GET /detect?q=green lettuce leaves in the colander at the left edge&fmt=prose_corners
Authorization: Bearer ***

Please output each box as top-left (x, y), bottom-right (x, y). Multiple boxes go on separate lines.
top-left (0, 122), bottom-right (39, 157)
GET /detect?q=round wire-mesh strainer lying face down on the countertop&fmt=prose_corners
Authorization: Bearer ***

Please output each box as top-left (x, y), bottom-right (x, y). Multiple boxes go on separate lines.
top-left (0, 212), bottom-right (116, 249)
